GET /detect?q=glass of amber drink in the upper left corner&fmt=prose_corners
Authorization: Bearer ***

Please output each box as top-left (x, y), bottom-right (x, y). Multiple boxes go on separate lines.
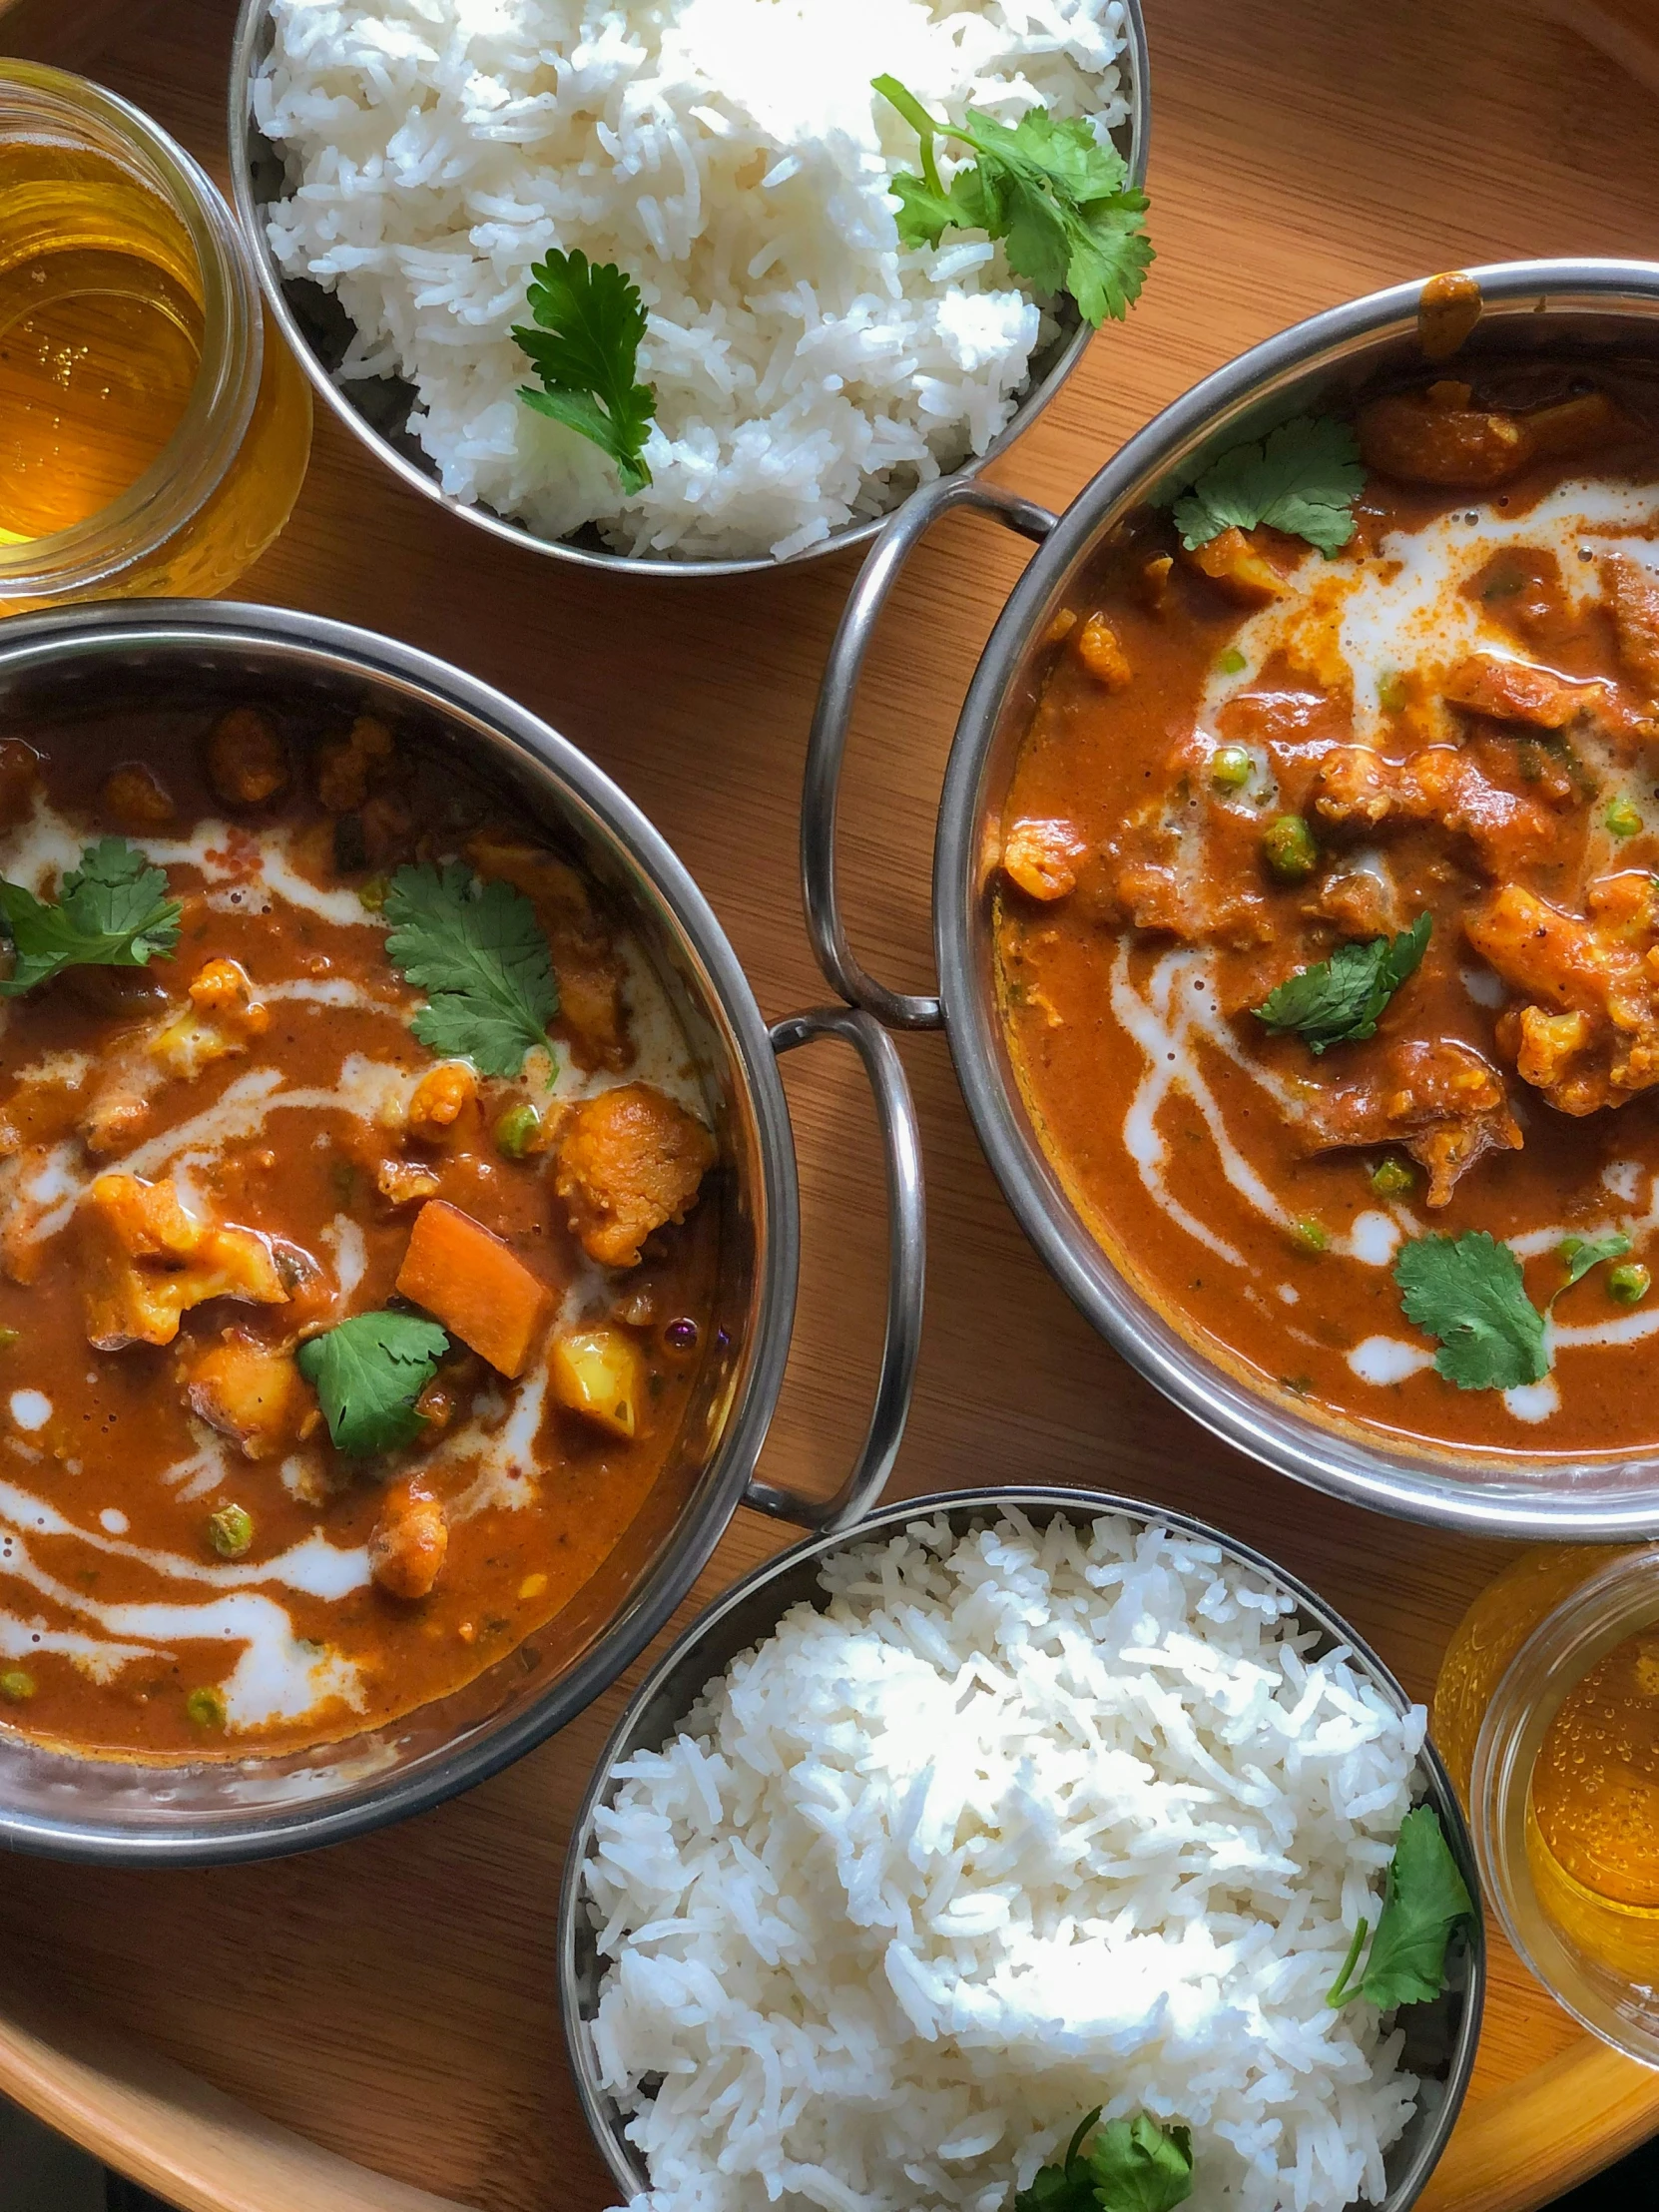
top-left (0, 60), bottom-right (311, 615)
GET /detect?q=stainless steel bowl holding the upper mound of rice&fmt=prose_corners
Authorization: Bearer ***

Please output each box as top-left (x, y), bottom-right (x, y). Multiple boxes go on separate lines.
top-left (230, 0), bottom-right (1148, 577)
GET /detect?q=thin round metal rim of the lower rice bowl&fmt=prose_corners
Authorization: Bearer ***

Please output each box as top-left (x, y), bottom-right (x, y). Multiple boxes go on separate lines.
top-left (555, 1482), bottom-right (1486, 2212)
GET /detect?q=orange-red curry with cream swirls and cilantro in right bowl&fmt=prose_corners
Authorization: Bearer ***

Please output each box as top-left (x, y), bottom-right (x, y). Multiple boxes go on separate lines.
top-left (995, 362), bottom-right (1659, 1455)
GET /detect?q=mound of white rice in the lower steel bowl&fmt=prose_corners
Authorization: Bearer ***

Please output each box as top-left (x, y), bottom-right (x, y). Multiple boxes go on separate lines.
top-left (586, 1517), bottom-right (1431, 2212)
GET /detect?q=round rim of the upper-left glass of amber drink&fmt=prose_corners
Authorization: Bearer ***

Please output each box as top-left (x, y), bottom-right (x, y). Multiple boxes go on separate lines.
top-left (0, 58), bottom-right (264, 602)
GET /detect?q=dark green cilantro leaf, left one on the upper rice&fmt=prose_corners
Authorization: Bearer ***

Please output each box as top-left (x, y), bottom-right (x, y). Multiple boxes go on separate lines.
top-left (513, 248), bottom-right (657, 498)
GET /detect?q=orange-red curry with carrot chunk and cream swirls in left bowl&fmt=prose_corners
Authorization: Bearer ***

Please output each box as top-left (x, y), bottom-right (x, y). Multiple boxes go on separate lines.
top-left (0, 701), bottom-right (717, 1759)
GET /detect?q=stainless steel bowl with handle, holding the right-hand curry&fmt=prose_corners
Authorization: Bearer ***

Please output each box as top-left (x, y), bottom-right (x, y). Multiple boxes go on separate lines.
top-left (801, 261), bottom-right (1659, 1542)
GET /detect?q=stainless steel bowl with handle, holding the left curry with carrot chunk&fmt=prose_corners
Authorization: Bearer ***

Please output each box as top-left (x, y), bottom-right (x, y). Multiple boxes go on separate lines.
top-left (0, 600), bottom-right (924, 1865)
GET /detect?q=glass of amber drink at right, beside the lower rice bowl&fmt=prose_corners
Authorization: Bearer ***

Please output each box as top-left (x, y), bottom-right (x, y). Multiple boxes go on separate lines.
top-left (1433, 1544), bottom-right (1659, 2066)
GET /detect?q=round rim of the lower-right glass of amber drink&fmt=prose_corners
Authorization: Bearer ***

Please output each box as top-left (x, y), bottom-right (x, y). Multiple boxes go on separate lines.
top-left (1468, 1542), bottom-right (1659, 2068)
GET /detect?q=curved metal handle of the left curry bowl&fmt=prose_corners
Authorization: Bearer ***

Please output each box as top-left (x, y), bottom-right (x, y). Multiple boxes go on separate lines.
top-left (744, 1006), bottom-right (927, 1535)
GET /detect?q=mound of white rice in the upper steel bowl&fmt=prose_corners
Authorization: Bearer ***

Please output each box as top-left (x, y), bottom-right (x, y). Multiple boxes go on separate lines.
top-left (255, 0), bottom-right (1126, 557)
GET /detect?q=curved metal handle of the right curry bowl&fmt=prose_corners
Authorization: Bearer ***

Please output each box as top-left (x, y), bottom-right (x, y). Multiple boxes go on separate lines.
top-left (801, 475), bottom-right (1059, 1028)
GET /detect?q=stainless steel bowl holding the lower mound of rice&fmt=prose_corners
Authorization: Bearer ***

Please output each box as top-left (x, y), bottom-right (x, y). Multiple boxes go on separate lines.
top-left (560, 1486), bottom-right (1486, 2212)
